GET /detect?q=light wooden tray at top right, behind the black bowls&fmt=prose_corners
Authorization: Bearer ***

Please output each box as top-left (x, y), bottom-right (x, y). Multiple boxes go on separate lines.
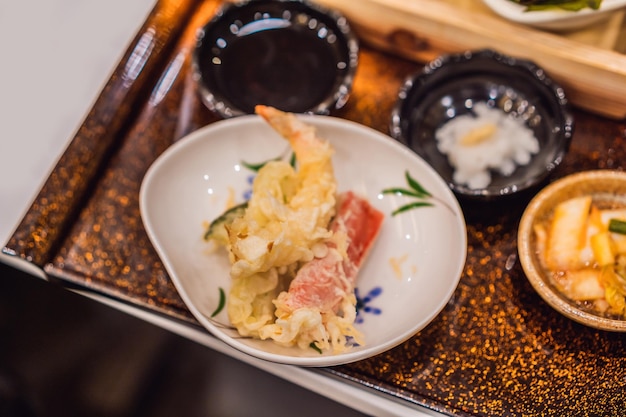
top-left (316, 0), bottom-right (626, 119)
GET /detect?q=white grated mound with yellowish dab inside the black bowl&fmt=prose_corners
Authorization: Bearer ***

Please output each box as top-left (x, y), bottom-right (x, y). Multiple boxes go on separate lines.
top-left (435, 102), bottom-right (539, 189)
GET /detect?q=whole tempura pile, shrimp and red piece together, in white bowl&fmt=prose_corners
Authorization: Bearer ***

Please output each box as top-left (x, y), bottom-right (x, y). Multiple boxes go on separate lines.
top-left (222, 106), bottom-right (383, 352)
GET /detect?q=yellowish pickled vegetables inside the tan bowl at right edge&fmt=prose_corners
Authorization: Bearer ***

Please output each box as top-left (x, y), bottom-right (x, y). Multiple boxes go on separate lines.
top-left (534, 196), bottom-right (626, 318)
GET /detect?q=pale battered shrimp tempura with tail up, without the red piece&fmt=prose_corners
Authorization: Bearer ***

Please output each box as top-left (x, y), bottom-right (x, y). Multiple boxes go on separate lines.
top-left (228, 106), bottom-right (337, 336)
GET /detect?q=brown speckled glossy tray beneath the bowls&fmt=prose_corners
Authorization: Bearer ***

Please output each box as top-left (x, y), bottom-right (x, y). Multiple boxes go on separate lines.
top-left (4, 0), bottom-right (626, 416)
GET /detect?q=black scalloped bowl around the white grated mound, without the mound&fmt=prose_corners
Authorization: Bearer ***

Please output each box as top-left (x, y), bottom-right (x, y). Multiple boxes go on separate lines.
top-left (390, 50), bottom-right (574, 200)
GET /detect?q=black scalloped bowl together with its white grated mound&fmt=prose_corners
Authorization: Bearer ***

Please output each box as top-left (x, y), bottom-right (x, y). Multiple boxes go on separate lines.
top-left (390, 50), bottom-right (574, 199)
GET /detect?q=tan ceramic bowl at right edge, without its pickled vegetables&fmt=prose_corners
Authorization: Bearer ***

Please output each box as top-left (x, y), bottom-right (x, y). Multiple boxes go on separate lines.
top-left (517, 170), bottom-right (626, 331)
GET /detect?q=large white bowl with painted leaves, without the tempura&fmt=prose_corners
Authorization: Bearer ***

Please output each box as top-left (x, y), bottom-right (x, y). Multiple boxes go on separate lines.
top-left (140, 115), bottom-right (467, 366)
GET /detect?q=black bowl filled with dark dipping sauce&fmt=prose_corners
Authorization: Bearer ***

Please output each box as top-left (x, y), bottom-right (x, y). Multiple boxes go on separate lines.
top-left (193, 0), bottom-right (358, 117)
